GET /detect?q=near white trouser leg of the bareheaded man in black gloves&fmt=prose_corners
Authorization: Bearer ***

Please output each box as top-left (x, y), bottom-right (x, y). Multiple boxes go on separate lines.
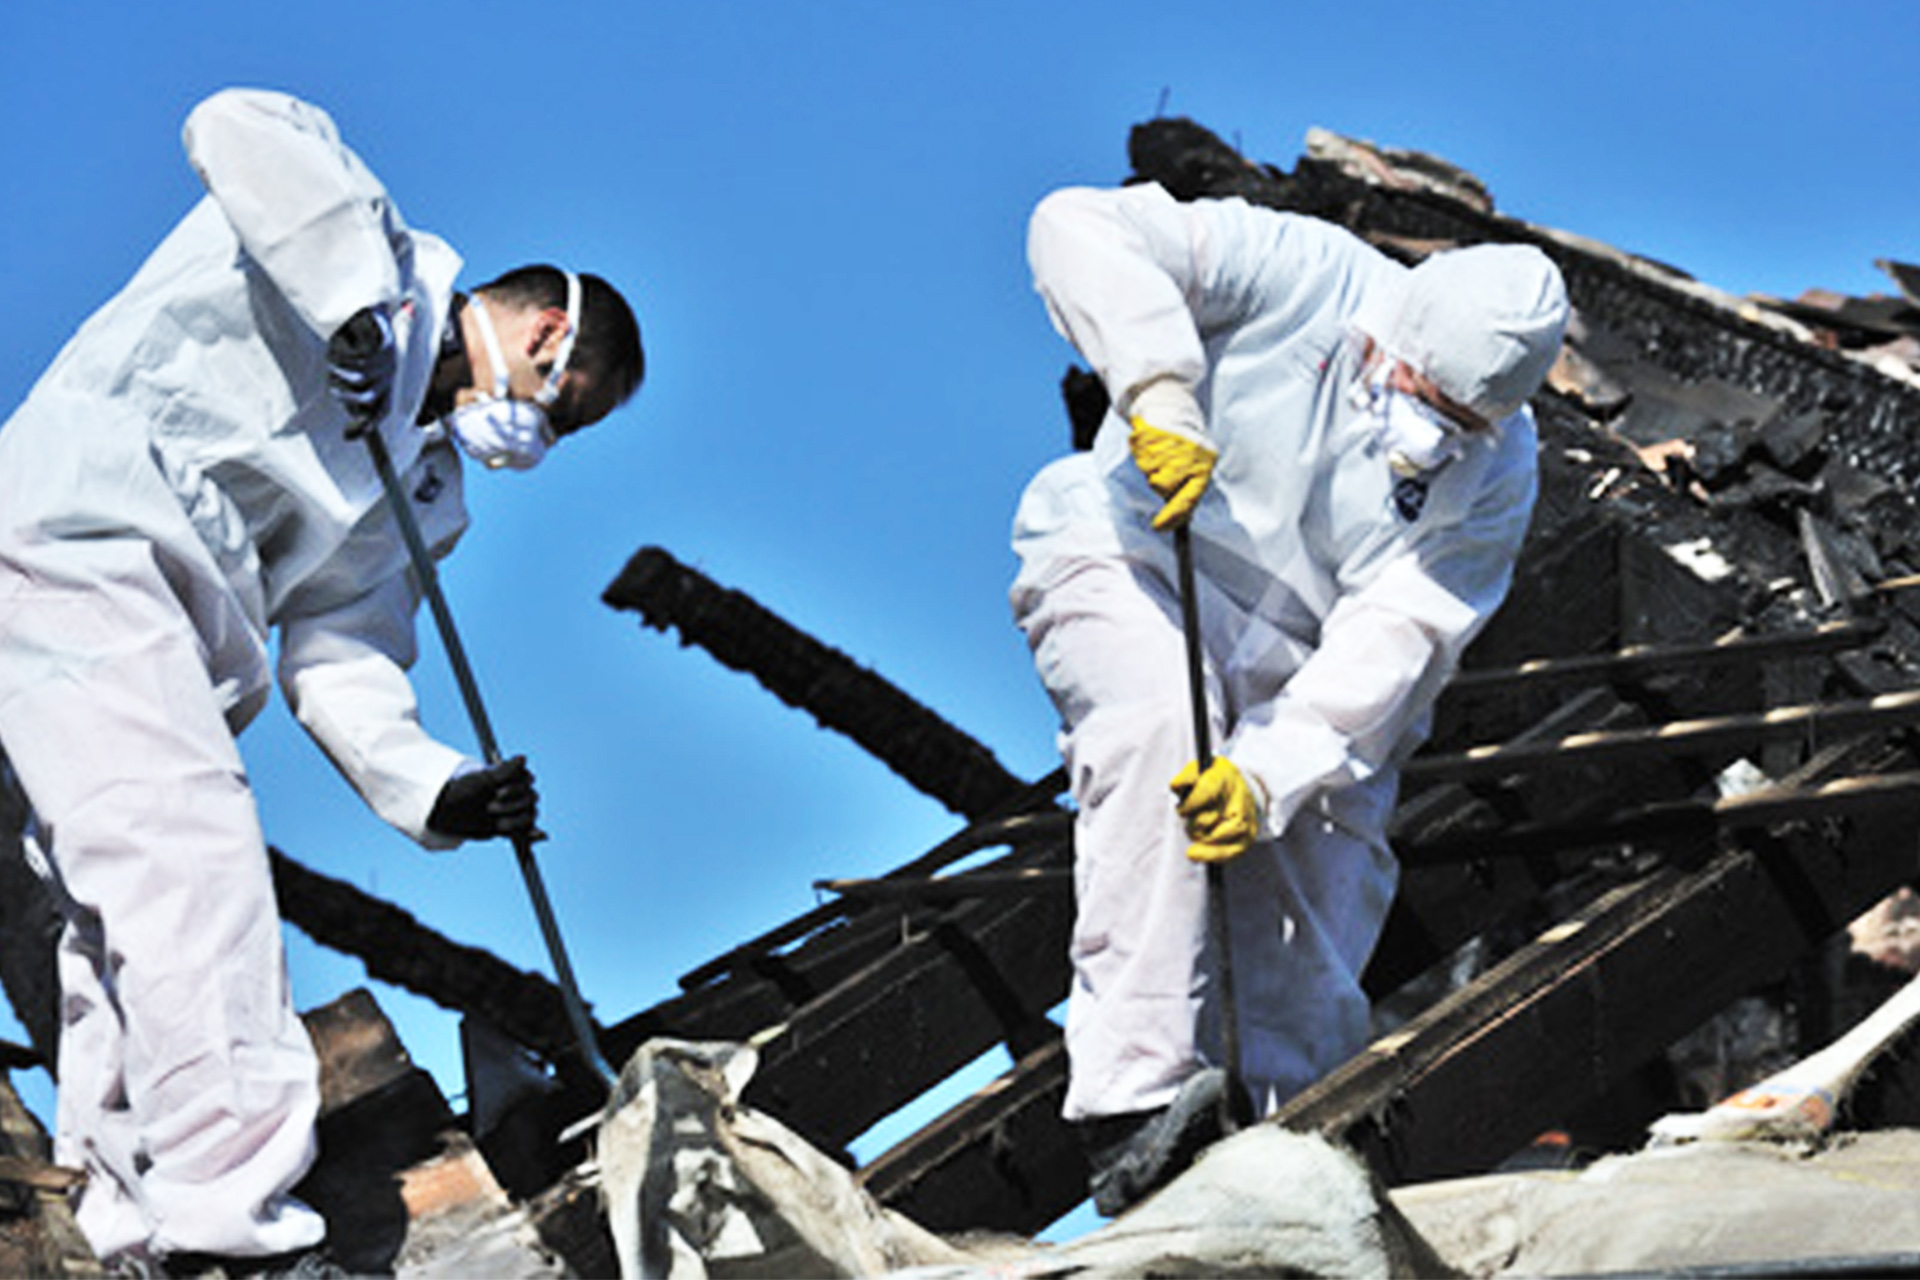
top-left (0, 539), bottom-right (324, 1255)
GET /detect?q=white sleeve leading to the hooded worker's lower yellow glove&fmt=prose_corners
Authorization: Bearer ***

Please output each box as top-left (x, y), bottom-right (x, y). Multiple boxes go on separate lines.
top-left (1223, 420), bottom-right (1536, 837)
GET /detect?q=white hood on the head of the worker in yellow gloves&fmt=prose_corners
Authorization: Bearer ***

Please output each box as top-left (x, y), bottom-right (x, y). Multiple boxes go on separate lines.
top-left (1354, 244), bottom-right (1567, 422)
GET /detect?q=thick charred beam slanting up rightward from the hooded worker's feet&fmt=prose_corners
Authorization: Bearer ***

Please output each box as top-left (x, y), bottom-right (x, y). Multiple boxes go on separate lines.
top-left (1277, 767), bottom-right (1920, 1182)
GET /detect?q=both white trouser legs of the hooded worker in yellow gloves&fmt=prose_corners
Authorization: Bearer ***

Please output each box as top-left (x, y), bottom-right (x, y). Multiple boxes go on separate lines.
top-left (1020, 557), bottom-right (1396, 1121)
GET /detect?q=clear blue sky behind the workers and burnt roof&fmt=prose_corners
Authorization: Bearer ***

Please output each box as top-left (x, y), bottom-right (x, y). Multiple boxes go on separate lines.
top-left (0, 0), bottom-right (1920, 1235)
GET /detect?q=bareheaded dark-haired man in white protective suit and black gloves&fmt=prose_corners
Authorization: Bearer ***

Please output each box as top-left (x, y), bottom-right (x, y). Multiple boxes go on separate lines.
top-left (0, 90), bottom-right (643, 1274)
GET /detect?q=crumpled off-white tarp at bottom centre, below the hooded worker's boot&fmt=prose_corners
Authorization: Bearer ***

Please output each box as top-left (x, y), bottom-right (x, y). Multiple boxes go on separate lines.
top-left (599, 1040), bottom-right (1444, 1280)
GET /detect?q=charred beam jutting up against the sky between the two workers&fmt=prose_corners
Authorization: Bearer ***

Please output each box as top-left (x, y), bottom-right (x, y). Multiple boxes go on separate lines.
top-left (603, 547), bottom-right (1023, 818)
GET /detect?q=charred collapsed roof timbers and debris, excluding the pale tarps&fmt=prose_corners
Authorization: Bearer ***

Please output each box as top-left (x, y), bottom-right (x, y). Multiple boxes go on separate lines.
top-left (0, 119), bottom-right (1920, 1274)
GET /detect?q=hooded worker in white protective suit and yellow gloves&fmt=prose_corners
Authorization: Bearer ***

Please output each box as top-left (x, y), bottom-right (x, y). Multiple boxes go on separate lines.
top-left (1012, 184), bottom-right (1567, 1215)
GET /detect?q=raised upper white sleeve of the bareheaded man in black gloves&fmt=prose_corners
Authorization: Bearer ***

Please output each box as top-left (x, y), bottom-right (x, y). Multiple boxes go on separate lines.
top-left (182, 88), bottom-right (405, 338)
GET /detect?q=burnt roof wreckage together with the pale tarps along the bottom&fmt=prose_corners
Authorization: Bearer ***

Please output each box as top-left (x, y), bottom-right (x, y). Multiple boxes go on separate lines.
top-left (11, 119), bottom-right (1920, 1276)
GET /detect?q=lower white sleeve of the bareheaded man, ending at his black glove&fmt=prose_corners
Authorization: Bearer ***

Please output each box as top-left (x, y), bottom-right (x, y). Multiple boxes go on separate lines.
top-left (280, 574), bottom-right (468, 848)
